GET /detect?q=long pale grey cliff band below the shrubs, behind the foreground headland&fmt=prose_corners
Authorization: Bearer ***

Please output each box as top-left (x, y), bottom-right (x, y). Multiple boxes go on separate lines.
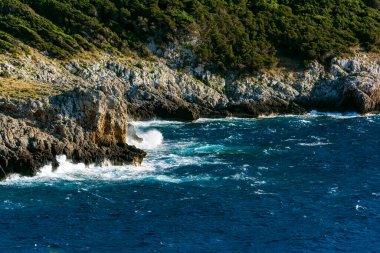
top-left (0, 49), bottom-right (380, 120)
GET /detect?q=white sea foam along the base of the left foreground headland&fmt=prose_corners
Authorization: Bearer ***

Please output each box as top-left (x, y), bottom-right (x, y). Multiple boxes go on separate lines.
top-left (0, 149), bottom-right (222, 186)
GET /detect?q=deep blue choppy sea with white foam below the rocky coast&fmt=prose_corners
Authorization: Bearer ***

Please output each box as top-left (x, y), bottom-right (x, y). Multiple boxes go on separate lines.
top-left (0, 112), bottom-right (380, 253)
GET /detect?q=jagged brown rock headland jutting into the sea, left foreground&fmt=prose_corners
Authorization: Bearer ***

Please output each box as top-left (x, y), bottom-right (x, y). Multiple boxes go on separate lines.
top-left (0, 88), bottom-right (146, 178)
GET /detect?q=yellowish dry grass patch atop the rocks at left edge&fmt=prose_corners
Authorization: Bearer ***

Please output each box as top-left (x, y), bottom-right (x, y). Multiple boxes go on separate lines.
top-left (0, 78), bottom-right (61, 99)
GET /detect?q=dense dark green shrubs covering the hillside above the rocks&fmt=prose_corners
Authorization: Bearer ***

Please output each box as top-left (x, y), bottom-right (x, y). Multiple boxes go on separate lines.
top-left (0, 0), bottom-right (380, 71)
